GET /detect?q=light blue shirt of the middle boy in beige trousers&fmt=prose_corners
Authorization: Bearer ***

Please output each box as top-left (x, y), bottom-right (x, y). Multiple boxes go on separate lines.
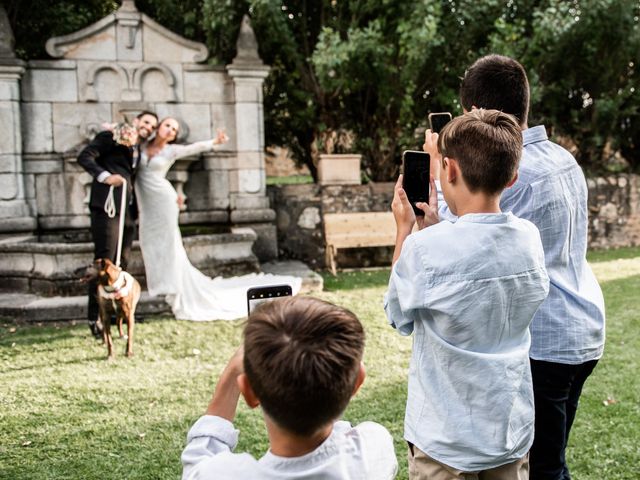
top-left (385, 213), bottom-right (549, 471)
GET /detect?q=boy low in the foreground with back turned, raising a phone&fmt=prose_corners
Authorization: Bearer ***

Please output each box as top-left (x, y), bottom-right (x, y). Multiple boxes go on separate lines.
top-left (182, 296), bottom-right (398, 480)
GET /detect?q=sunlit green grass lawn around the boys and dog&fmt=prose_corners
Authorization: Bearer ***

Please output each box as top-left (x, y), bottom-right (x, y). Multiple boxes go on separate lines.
top-left (0, 249), bottom-right (640, 480)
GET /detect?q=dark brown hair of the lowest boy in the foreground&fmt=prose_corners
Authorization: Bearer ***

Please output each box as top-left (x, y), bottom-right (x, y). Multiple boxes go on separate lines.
top-left (244, 296), bottom-right (364, 436)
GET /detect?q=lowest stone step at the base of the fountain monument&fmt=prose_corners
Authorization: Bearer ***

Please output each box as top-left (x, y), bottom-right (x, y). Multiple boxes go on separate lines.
top-left (0, 261), bottom-right (323, 323)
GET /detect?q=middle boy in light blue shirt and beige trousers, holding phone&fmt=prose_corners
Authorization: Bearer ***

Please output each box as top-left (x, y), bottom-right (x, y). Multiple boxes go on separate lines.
top-left (385, 110), bottom-right (549, 480)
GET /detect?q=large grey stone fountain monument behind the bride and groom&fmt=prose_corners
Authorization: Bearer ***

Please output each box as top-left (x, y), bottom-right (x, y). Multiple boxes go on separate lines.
top-left (0, 0), bottom-right (308, 312)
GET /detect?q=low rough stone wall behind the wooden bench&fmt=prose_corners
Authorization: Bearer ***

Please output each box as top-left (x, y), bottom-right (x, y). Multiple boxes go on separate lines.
top-left (268, 175), bottom-right (640, 269)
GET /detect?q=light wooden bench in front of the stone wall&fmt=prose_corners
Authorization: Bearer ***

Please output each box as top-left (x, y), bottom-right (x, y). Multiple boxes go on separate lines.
top-left (323, 212), bottom-right (396, 275)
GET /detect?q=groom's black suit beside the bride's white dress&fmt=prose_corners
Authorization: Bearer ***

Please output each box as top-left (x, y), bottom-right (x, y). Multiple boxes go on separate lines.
top-left (78, 131), bottom-right (138, 330)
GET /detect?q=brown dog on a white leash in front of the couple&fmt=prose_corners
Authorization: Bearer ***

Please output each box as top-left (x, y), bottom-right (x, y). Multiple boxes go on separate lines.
top-left (96, 258), bottom-right (142, 359)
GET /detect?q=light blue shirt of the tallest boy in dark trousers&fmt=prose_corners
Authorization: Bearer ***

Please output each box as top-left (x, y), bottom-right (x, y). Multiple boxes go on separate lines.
top-left (438, 125), bottom-right (605, 364)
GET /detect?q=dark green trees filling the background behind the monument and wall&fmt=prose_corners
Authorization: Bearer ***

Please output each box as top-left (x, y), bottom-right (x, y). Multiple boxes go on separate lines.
top-left (2, 0), bottom-right (640, 176)
